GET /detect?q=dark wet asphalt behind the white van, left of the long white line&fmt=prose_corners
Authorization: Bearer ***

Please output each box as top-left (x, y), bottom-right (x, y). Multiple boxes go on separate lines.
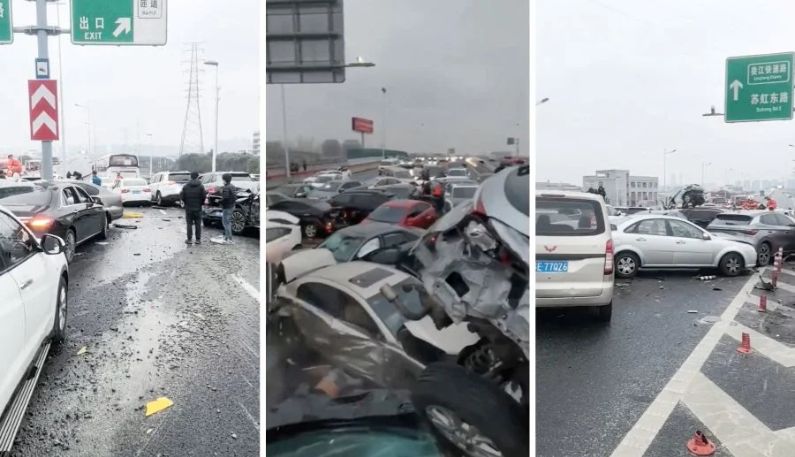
top-left (536, 272), bottom-right (749, 457)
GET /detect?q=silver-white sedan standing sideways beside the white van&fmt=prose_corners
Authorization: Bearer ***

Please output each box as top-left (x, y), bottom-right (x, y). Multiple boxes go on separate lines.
top-left (613, 215), bottom-right (756, 278)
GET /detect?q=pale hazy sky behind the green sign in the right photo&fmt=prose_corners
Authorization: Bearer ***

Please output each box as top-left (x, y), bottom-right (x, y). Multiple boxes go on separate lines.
top-left (535, 0), bottom-right (795, 184)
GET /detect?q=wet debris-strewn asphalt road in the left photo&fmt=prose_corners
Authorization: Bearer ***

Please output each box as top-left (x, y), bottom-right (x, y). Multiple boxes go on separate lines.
top-left (11, 208), bottom-right (260, 457)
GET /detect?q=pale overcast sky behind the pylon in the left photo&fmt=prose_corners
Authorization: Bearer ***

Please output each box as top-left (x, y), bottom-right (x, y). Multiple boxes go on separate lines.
top-left (0, 0), bottom-right (255, 154)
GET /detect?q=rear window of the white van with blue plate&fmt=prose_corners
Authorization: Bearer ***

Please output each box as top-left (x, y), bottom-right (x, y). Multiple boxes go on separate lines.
top-left (536, 197), bottom-right (605, 236)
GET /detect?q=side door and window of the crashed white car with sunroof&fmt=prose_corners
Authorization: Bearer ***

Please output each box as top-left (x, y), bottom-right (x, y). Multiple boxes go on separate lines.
top-left (293, 280), bottom-right (383, 382)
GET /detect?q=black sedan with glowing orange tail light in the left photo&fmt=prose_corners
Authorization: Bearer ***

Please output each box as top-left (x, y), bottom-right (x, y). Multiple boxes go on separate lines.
top-left (0, 183), bottom-right (109, 262)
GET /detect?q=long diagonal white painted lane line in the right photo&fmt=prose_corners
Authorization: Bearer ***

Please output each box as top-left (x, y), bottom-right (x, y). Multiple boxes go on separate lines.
top-left (610, 275), bottom-right (760, 457)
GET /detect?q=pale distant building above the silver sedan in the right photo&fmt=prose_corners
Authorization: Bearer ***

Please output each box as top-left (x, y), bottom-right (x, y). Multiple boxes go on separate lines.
top-left (582, 170), bottom-right (659, 206)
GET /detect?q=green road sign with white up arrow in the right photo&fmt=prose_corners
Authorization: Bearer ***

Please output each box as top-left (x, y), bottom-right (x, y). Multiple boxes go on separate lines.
top-left (724, 52), bottom-right (793, 122)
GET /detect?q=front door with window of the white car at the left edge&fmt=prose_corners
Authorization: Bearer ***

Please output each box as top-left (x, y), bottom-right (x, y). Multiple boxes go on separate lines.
top-left (0, 212), bottom-right (51, 362)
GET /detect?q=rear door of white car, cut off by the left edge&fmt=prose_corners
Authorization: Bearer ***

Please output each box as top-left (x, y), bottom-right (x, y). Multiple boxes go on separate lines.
top-left (0, 230), bottom-right (27, 414)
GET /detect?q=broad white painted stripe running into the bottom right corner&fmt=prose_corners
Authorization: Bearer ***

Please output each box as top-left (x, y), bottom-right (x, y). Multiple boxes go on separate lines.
top-left (683, 373), bottom-right (795, 457)
